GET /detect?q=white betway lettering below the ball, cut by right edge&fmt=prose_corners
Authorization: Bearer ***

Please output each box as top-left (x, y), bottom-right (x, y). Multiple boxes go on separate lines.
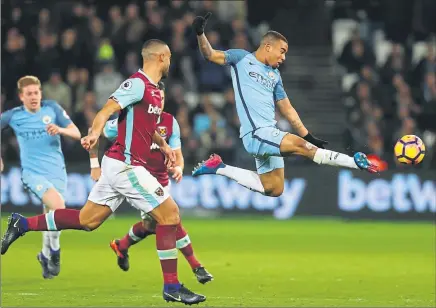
top-left (338, 171), bottom-right (436, 213)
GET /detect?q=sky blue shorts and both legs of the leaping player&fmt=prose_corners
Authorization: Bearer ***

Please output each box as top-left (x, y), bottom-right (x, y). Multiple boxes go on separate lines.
top-left (192, 127), bottom-right (377, 197)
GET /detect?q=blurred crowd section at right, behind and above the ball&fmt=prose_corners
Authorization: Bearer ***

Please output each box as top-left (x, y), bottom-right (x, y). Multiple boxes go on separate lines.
top-left (337, 1), bottom-right (436, 166)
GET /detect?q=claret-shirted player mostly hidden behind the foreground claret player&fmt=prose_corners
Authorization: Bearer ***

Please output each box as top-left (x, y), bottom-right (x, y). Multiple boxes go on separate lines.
top-left (89, 81), bottom-right (213, 284)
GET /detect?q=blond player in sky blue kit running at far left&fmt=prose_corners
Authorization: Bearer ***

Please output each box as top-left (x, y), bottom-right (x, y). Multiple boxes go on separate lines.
top-left (1, 76), bottom-right (80, 279)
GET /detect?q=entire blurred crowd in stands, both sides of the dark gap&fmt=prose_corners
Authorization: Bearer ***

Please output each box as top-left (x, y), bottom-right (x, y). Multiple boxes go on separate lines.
top-left (1, 0), bottom-right (436, 171)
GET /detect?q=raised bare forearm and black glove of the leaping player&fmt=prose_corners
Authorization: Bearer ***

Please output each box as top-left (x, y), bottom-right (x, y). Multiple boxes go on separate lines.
top-left (192, 12), bottom-right (226, 65)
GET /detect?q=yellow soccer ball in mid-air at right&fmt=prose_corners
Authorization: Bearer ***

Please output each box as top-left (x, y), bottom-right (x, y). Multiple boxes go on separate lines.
top-left (394, 135), bottom-right (425, 165)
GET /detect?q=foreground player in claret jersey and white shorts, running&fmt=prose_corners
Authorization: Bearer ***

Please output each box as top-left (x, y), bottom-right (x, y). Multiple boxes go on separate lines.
top-left (1, 39), bottom-right (206, 304)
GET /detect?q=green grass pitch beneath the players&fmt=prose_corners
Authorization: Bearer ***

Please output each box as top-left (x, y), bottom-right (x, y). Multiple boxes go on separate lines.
top-left (1, 213), bottom-right (435, 307)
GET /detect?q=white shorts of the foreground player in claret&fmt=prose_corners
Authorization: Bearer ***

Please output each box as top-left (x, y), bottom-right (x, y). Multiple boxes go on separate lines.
top-left (88, 156), bottom-right (169, 213)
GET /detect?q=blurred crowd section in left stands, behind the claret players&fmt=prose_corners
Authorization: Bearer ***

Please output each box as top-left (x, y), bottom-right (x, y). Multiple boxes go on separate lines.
top-left (1, 0), bottom-right (255, 163)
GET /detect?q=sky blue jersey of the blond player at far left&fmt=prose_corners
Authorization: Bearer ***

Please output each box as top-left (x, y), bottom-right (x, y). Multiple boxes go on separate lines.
top-left (1, 100), bottom-right (72, 178)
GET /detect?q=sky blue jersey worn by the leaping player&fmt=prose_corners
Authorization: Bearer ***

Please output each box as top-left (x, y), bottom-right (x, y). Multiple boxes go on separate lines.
top-left (224, 49), bottom-right (287, 137)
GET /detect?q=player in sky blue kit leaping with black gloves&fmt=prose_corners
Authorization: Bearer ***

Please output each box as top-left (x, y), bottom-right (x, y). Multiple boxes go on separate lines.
top-left (193, 13), bottom-right (377, 197)
